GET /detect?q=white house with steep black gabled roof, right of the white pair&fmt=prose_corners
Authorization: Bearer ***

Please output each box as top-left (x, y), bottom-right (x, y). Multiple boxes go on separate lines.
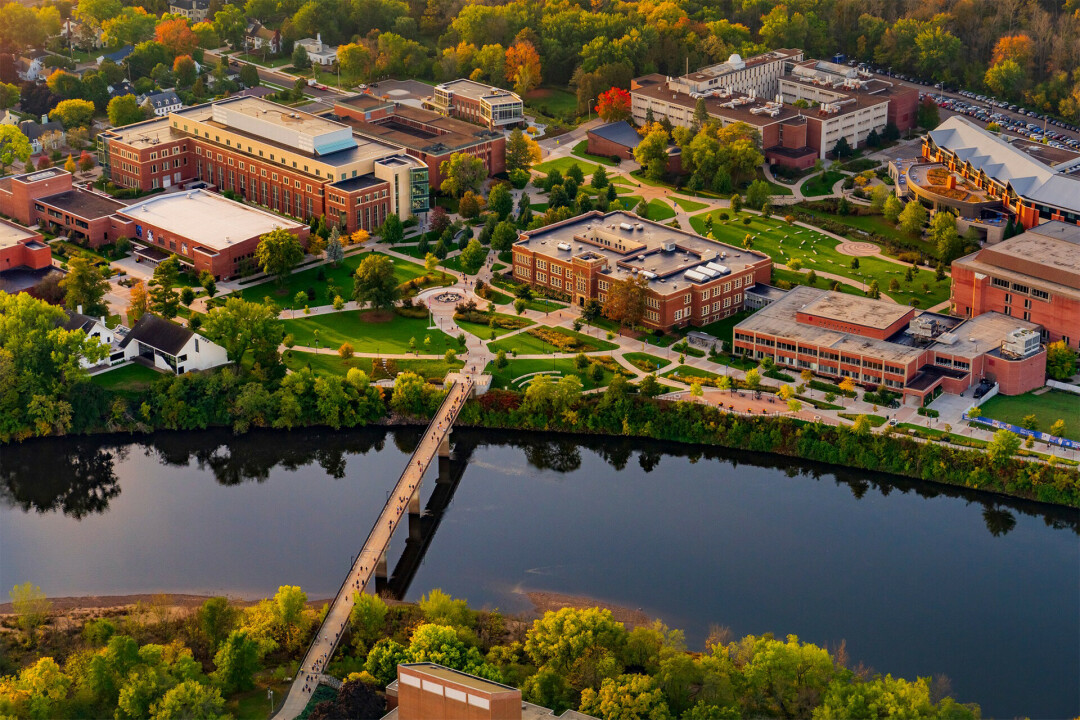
top-left (120, 313), bottom-right (229, 375)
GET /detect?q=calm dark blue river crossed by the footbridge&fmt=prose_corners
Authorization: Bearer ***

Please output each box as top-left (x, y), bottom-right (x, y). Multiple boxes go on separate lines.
top-left (0, 430), bottom-right (1080, 718)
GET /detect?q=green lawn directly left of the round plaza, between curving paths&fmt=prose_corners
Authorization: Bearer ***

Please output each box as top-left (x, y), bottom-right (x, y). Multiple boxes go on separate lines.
top-left (284, 310), bottom-right (461, 355)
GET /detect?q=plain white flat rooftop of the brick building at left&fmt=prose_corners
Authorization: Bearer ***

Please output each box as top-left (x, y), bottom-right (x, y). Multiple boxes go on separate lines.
top-left (122, 190), bottom-right (301, 250)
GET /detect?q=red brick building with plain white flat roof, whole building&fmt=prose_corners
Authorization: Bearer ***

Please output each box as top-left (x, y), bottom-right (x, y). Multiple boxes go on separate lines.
top-left (120, 190), bottom-right (309, 280)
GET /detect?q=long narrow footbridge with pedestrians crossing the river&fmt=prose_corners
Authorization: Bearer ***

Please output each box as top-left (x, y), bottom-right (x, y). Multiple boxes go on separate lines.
top-left (274, 375), bottom-right (473, 720)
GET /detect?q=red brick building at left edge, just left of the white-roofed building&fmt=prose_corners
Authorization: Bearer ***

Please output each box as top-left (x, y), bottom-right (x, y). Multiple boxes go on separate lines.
top-left (0, 167), bottom-right (130, 247)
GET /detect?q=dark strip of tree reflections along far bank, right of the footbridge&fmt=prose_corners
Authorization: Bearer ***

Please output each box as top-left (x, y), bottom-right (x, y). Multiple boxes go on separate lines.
top-left (455, 431), bottom-right (1080, 538)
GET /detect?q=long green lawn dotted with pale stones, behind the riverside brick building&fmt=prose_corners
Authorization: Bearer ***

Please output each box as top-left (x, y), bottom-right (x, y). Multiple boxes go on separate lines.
top-left (690, 210), bottom-right (949, 308)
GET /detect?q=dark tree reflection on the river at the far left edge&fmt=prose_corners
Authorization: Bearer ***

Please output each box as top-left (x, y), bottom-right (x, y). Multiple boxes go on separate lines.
top-left (0, 438), bottom-right (127, 518)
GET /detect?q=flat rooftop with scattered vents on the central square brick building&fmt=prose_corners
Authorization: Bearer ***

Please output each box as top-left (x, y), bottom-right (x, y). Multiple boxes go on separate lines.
top-left (515, 210), bottom-right (768, 294)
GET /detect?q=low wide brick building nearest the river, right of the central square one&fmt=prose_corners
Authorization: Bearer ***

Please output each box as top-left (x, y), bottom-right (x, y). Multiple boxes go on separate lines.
top-left (734, 286), bottom-right (1047, 405)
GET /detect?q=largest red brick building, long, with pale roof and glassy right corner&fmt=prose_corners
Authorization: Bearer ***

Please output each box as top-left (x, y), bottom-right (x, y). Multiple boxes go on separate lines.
top-left (99, 97), bottom-right (429, 232)
